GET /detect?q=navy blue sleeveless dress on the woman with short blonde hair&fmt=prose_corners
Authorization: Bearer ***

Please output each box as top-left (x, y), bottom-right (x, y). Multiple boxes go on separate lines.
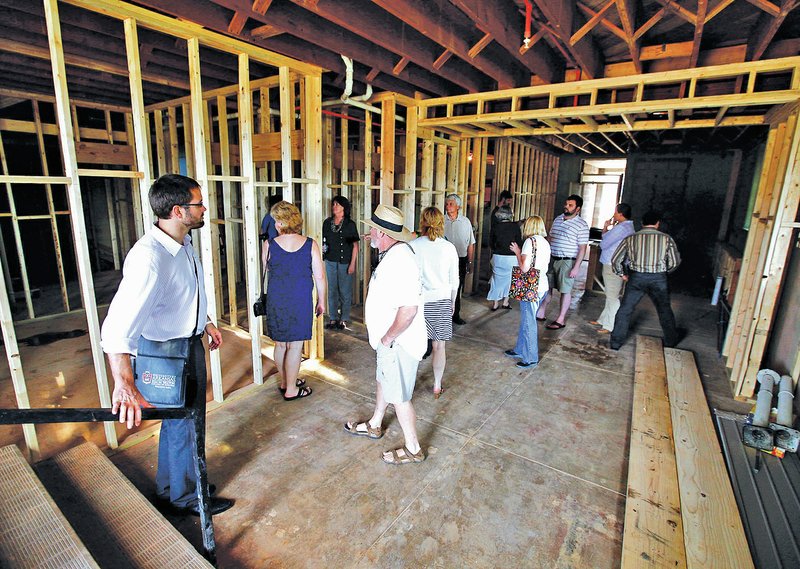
top-left (266, 239), bottom-right (314, 342)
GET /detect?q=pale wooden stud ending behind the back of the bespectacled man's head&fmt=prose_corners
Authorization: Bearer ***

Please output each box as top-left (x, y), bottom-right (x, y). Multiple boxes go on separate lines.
top-left (124, 18), bottom-right (155, 231)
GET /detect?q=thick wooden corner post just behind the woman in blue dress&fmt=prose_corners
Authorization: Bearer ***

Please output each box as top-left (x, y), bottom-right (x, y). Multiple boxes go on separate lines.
top-left (302, 75), bottom-right (330, 360)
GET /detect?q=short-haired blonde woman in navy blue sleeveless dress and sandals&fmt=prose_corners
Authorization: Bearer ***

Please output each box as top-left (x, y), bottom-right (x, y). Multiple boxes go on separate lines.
top-left (261, 201), bottom-right (327, 401)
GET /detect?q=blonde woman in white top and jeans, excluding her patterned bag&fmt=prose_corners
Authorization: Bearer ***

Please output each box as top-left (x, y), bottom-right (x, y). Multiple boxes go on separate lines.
top-left (506, 215), bottom-right (550, 368)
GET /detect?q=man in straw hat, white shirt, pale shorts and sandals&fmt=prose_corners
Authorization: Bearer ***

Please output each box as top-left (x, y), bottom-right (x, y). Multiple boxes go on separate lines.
top-left (344, 205), bottom-right (427, 464)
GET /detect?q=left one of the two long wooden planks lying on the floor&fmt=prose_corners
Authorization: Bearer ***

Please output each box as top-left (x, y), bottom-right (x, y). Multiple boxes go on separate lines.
top-left (621, 336), bottom-right (686, 569)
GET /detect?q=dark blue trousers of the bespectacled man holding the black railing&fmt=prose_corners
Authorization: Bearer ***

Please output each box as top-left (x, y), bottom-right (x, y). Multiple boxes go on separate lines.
top-left (156, 336), bottom-right (206, 508)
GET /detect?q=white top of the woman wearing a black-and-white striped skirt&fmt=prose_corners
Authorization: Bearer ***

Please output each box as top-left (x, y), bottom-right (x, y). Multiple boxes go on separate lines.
top-left (409, 236), bottom-right (458, 302)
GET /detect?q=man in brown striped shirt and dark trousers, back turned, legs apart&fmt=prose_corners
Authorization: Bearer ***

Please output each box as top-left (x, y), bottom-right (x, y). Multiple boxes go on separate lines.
top-left (611, 211), bottom-right (681, 350)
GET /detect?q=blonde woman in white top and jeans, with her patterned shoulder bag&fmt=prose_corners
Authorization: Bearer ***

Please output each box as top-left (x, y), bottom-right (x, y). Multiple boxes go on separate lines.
top-left (505, 215), bottom-right (550, 368)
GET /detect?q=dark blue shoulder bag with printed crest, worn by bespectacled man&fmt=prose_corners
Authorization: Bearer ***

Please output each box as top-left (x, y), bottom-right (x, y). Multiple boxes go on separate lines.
top-left (131, 251), bottom-right (202, 409)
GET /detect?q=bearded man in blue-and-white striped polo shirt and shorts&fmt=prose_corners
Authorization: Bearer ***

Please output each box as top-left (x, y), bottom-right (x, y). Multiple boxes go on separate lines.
top-left (536, 194), bottom-right (589, 330)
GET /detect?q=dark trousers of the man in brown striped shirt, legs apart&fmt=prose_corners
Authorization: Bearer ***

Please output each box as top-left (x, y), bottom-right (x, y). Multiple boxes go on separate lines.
top-left (611, 272), bottom-right (678, 348)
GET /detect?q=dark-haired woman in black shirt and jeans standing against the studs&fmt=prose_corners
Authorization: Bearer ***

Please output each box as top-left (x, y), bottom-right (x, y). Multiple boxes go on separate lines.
top-left (322, 196), bottom-right (359, 330)
